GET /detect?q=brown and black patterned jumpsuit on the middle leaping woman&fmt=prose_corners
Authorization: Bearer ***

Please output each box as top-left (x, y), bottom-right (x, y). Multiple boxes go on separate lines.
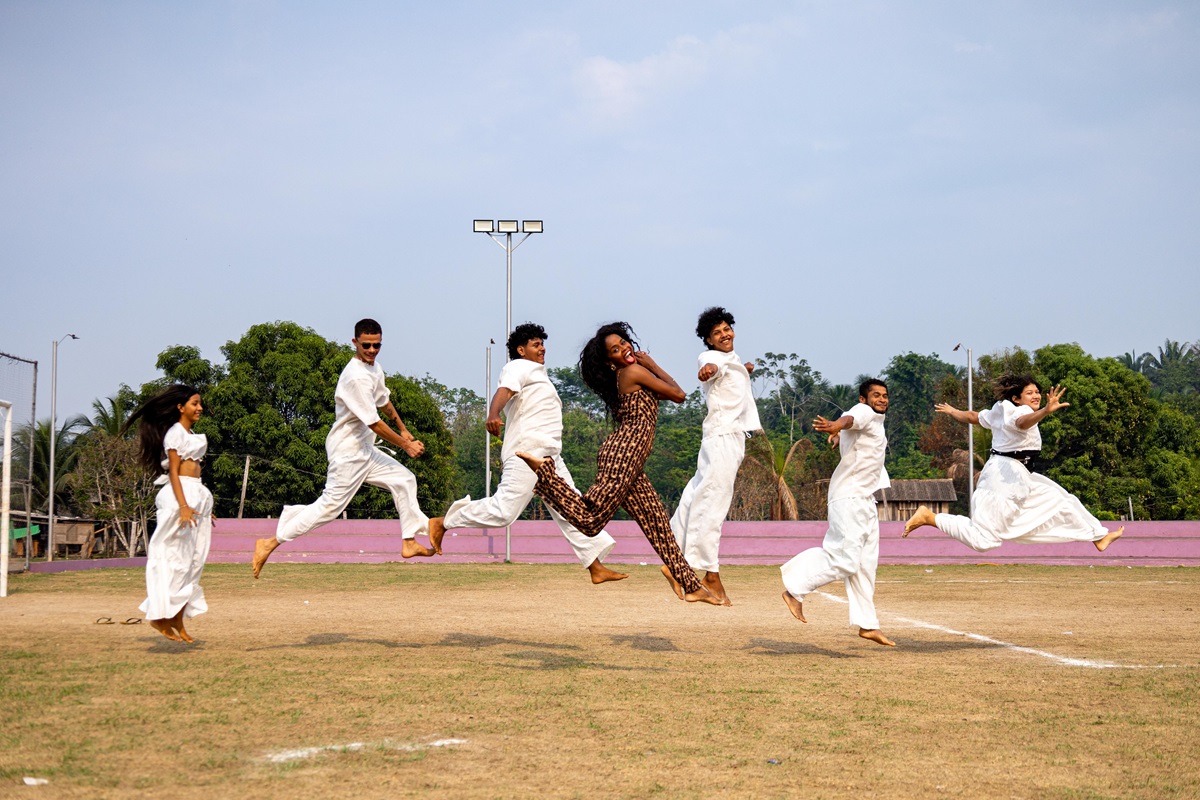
top-left (533, 389), bottom-right (702, 594)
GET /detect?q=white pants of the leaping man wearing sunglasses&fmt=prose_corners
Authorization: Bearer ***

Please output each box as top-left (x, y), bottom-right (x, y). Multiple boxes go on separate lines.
top-left (275, 447), bottom-right (430, 542)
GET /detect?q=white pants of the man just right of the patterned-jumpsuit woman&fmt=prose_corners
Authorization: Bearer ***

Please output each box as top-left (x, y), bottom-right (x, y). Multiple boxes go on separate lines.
top-left (671, 433), bottom-right (746, 572)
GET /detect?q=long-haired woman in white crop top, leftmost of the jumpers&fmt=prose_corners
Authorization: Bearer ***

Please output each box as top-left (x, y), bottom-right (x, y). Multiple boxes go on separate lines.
top-left (125, 384), bottom-right (212, 642)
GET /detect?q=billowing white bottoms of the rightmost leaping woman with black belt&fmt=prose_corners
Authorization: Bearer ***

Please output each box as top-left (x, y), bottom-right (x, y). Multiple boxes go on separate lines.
top-left (935, 456), bottom-right (1109, 553)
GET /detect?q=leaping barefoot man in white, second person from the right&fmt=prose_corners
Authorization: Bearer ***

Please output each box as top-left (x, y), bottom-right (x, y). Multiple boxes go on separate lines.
top-left (780, 379), bottom-right (895, 648)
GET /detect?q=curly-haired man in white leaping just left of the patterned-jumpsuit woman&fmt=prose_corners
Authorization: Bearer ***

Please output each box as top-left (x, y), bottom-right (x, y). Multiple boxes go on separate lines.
top-left (430, 323), bottom-right (629, 583)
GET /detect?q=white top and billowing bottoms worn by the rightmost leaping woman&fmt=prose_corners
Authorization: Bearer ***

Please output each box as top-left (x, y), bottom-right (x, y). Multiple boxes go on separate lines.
top-left (936, 399), bottom-right (1109, 553)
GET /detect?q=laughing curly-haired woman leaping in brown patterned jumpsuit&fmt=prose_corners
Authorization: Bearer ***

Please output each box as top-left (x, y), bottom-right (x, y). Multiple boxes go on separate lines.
top-left (517, 323), bottom-right (721, 606)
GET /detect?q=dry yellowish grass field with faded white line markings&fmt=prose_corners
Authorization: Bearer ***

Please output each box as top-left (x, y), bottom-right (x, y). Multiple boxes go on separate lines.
top-left (0, 564), bottom-right (1200, 799)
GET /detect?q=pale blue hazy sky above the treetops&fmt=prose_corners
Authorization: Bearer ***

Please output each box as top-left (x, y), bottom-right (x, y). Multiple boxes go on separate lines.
top-left (0, 0), bottom-right (1200, 431)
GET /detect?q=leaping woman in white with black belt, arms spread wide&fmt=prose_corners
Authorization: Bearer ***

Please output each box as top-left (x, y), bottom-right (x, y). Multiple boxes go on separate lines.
top-left (904, 375), bottom-right (1124, 553)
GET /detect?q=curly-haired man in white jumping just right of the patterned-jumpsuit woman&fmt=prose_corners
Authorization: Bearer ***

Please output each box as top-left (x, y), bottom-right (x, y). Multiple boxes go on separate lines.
top-left (671, 306), bottom-right (762, 606)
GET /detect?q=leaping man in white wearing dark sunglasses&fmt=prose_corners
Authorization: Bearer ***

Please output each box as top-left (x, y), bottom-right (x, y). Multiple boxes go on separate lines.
top-left (252, 319), bottom-right (437, 578)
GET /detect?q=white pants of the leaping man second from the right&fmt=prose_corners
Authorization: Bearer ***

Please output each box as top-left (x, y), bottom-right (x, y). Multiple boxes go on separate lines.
top-left (779, 498), bottom-right (880, 631)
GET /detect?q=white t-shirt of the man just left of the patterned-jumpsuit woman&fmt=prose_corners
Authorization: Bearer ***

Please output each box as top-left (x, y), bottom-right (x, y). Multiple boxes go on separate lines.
top-left (498, 359), bottom-right (563, 461)
